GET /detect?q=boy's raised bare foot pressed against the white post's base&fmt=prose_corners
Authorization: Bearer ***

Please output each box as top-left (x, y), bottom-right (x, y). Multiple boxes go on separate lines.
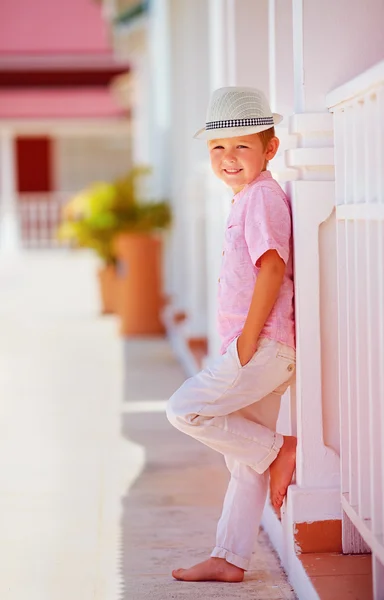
top-left (269, 435), bottom-right (297, 509)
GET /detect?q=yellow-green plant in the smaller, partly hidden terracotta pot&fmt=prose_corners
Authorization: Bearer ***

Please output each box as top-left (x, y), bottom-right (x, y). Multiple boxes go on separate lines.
top-left (58, 182), bottom-right (117, 314)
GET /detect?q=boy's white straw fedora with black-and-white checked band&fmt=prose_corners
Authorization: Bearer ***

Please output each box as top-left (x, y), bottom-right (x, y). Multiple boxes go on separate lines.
top-left (193, 87), bottom-right (283, 140)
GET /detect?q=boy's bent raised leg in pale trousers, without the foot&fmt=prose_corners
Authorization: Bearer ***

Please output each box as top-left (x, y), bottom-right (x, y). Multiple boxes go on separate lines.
top-left (167, 339), bottom-right (295, 473)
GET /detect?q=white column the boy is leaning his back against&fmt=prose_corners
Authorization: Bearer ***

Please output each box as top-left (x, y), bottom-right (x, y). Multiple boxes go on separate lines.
top-left (280, 0), bottom-right (341, 523)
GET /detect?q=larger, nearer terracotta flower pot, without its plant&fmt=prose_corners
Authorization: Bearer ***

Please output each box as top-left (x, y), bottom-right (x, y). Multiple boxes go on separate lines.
top-left (114, 233), bottom-right (164, 336)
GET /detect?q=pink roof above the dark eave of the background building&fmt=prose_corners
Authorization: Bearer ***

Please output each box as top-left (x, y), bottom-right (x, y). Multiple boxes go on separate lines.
top-left (0, 0), bottom-right (110, 54)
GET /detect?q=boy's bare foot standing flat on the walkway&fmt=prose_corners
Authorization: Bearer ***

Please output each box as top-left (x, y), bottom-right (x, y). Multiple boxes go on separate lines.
top-left (172, 556), bottom-right (244, 583)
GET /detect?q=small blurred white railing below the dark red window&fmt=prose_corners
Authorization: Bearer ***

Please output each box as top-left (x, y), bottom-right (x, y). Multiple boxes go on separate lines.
top-left (17, 192), bottom-right (71, 248)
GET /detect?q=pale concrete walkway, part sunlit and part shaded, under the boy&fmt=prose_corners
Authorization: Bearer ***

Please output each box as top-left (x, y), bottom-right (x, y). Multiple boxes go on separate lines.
top-left (0, 252), bottom-right (295, 600)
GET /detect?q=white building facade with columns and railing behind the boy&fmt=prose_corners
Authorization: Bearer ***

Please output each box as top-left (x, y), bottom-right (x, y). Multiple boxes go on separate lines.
top-left (105, 0), bottom-right (384, 600)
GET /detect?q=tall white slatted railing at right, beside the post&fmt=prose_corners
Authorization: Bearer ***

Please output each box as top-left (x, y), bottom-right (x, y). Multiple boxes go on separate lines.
top-left (327, 62), bottom-right (384, 600)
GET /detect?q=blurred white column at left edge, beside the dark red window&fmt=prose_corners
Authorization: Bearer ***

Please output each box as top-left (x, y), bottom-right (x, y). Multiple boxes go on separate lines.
top-left (0, 129), bottom-right (21, 252)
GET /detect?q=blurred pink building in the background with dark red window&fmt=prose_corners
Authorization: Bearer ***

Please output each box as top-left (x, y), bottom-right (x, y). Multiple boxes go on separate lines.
top-left (0, 0), bottom-right (130, 247)
